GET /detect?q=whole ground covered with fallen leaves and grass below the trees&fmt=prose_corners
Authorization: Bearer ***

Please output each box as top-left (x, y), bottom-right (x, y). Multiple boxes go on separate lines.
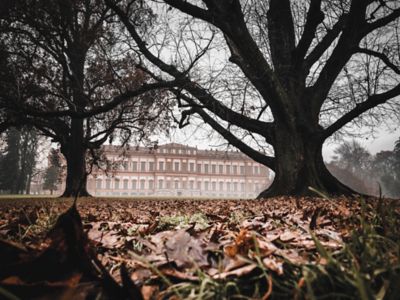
top-left (0, 197), bottom-right (400, 299)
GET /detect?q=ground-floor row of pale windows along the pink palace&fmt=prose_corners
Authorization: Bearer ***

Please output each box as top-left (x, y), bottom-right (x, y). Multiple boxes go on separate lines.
top-left (96, 178), bottom-right (260, 192)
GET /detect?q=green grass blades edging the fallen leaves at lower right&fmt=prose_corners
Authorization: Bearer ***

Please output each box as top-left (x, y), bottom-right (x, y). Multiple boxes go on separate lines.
top-left (135, 199), bottom-right (400, 300)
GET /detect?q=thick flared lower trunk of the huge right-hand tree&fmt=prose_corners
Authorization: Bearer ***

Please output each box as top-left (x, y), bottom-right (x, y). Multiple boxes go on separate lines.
top-left (257, 126), bottom-right (358, 198)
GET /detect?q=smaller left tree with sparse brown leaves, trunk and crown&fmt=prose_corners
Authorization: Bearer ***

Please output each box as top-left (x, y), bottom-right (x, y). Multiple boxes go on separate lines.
top-left (0, 0), bottom-right (173, 197)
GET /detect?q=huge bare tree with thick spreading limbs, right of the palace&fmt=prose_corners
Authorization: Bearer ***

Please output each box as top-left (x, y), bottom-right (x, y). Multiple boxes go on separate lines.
top-left (106, 0), bottom-right (400, 197)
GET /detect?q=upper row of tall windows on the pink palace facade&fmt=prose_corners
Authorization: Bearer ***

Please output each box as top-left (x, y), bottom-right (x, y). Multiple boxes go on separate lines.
top-left (122, 161), bottom-right (260, 175)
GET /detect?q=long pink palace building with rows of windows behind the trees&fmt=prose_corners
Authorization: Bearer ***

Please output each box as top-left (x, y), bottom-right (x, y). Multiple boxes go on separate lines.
top-left (83, 143), bottom-right (271, 198)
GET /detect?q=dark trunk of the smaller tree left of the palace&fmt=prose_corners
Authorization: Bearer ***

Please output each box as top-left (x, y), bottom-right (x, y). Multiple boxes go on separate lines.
top-left (61, 119), bottom-right (90, 197)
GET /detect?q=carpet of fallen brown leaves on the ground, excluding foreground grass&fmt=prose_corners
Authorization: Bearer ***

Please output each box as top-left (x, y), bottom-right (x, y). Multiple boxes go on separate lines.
top-left (0, 197), bottom-right (399, 299)
